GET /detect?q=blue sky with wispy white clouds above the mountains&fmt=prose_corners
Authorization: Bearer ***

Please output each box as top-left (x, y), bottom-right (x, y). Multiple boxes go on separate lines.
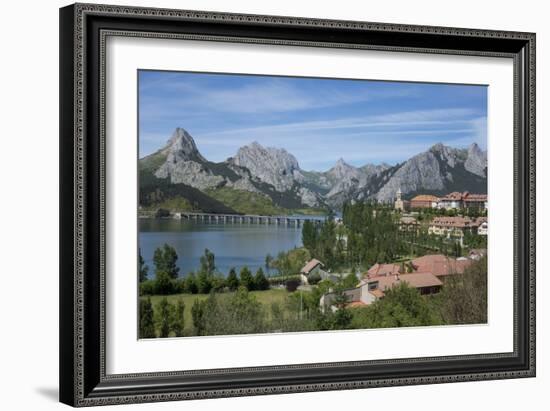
top-left (139, 71), bottom-right (487, 171)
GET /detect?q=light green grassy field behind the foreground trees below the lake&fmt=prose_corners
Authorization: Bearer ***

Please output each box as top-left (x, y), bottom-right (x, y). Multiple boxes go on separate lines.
top-left (141, 288), bottom-right (298, 331)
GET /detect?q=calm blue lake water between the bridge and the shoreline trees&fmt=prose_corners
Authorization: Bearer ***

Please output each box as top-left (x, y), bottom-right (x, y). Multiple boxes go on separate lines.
top-left (139, 219), bottom-right (310, 277)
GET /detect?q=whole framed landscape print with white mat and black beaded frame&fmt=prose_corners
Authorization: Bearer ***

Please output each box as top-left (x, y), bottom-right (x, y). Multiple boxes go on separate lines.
top-left (60, 4), bottom-right (535, 406)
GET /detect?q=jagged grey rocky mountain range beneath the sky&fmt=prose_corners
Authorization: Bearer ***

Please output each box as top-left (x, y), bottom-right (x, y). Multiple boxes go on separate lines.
top-left (139, 128), bottom-right (487, 212)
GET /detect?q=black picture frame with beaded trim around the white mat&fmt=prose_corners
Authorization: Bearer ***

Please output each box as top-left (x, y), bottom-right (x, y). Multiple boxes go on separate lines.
top-left (60, 4), bottom-right (535, 406)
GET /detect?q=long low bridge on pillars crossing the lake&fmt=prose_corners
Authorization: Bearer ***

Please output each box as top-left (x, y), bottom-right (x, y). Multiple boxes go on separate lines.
top-left (140, 211), bottom-right (325, 227)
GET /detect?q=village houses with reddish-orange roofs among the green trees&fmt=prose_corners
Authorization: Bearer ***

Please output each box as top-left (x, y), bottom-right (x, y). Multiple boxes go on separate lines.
top-left (299, 190), bottom-right (488, 311)
